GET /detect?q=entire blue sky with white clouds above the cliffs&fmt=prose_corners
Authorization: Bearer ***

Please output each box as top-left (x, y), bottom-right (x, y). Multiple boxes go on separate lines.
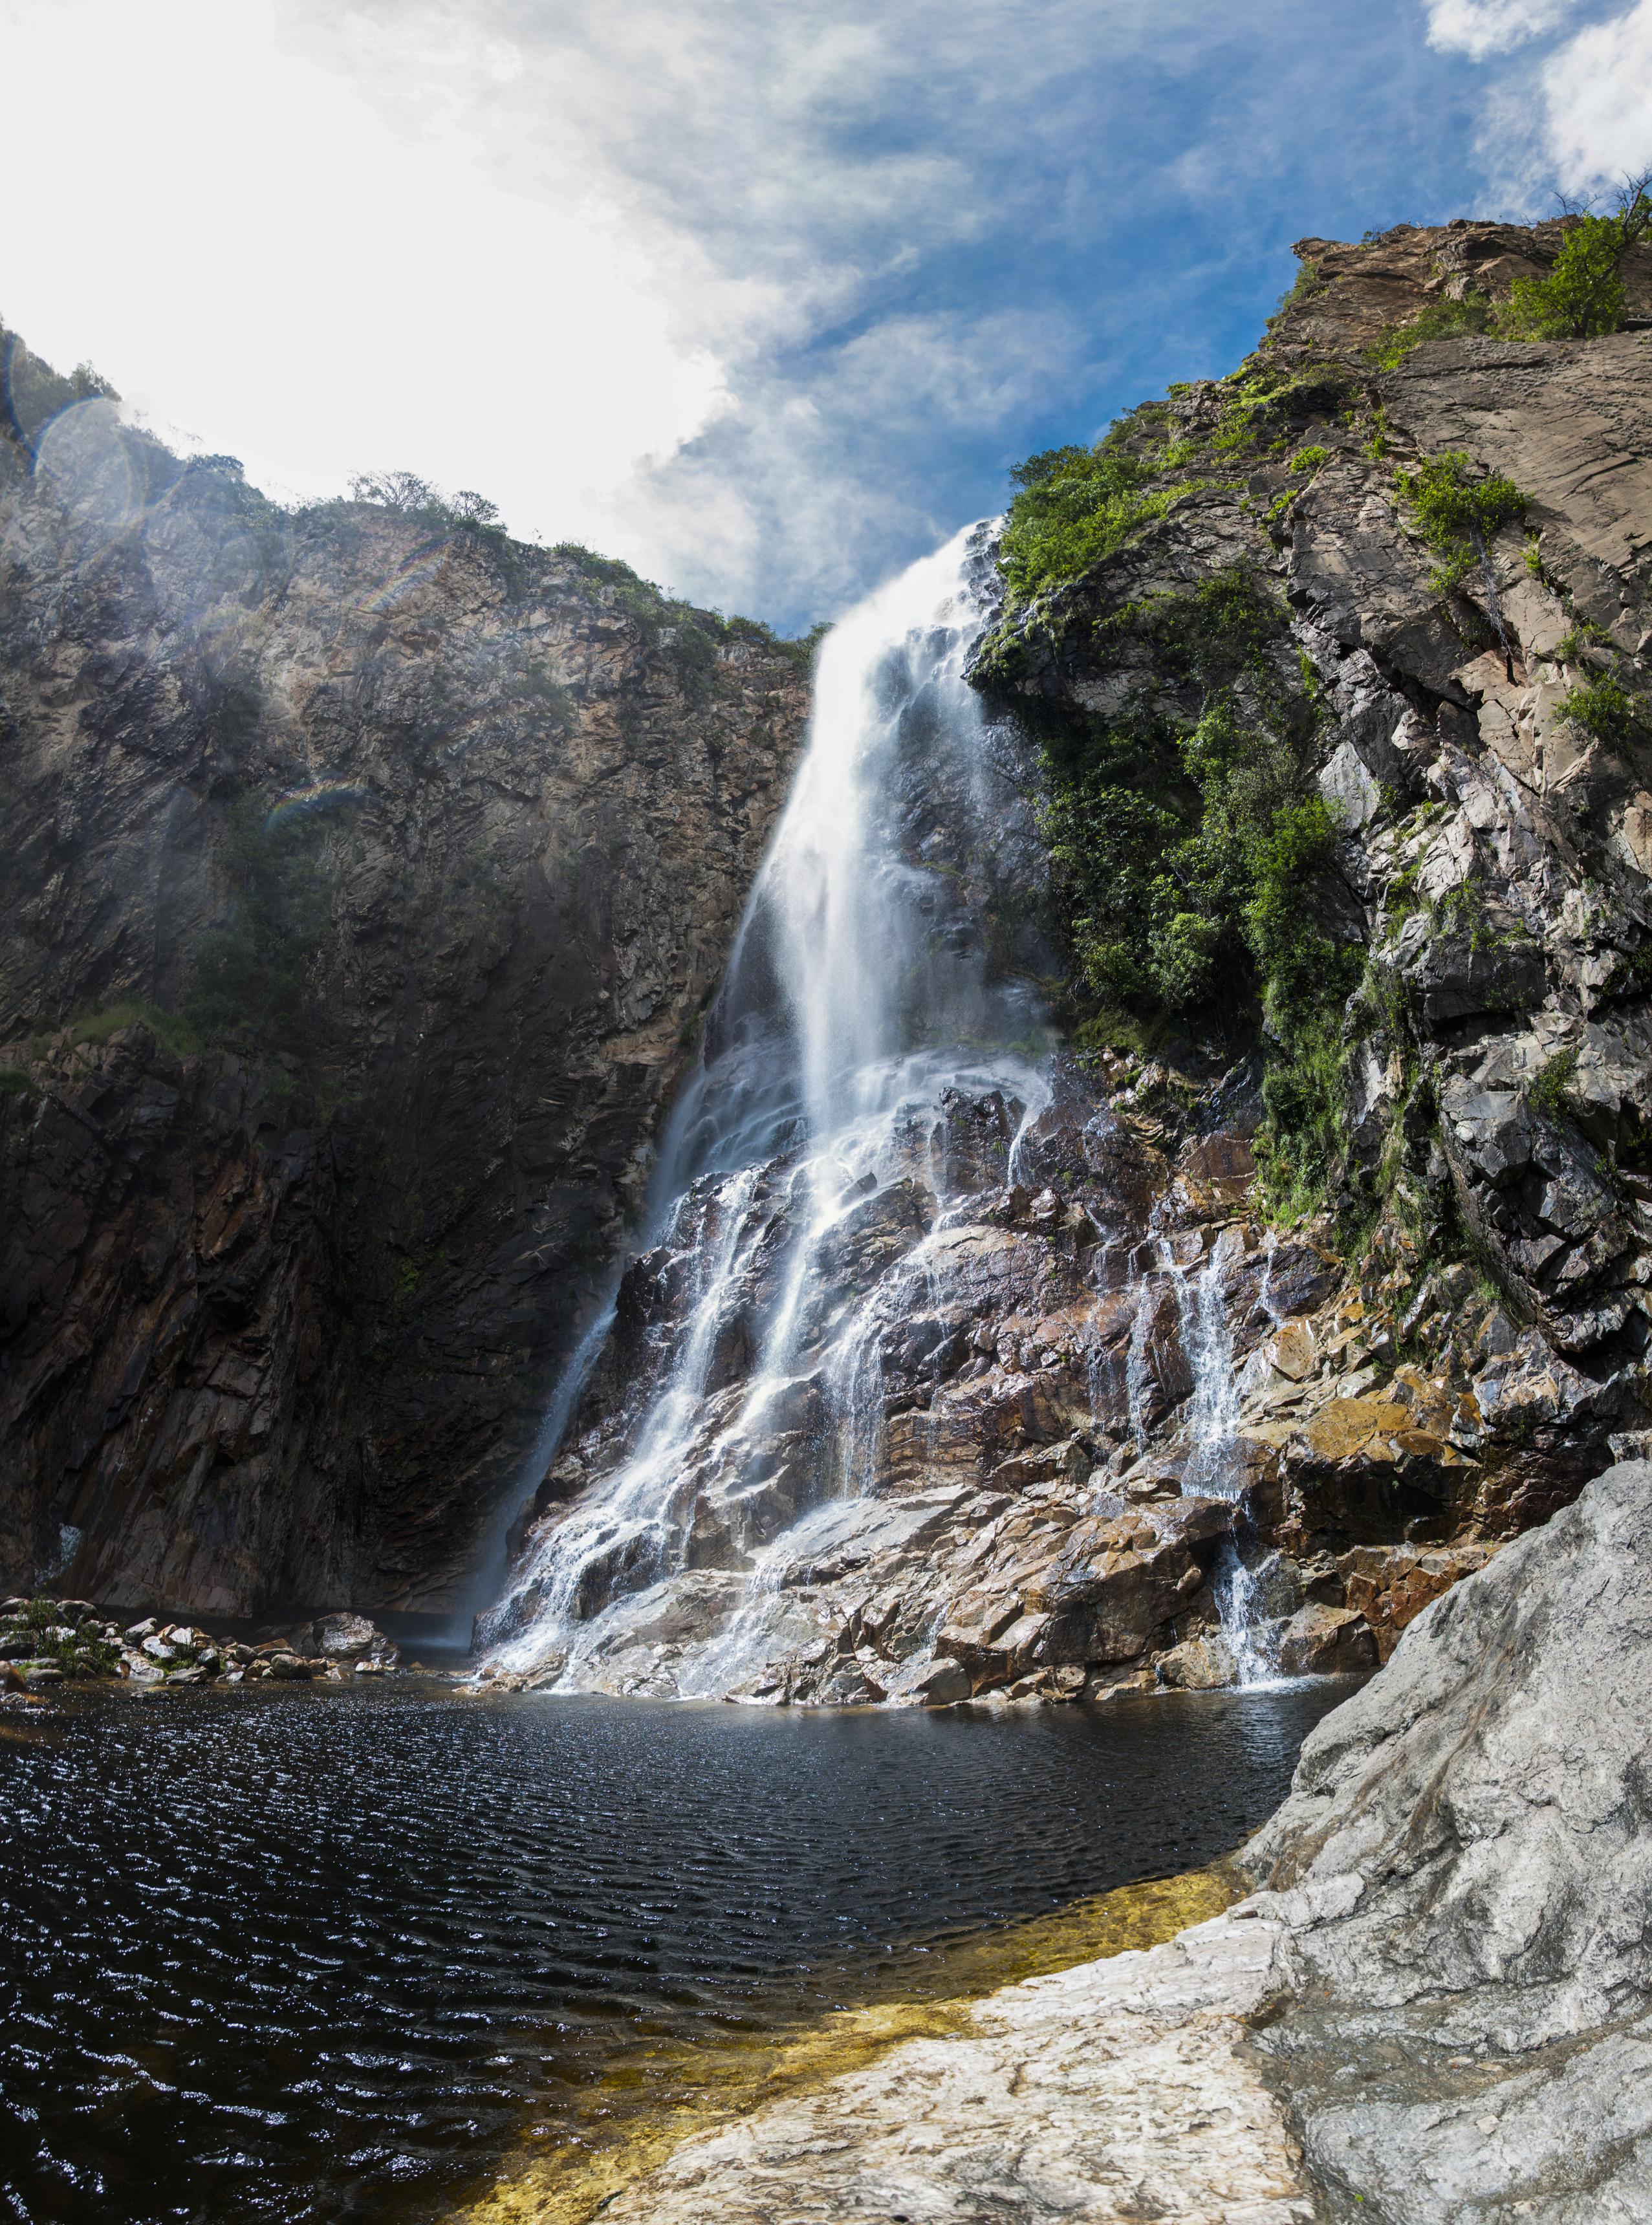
top-left (0, 0), bottom-right (1652, 632)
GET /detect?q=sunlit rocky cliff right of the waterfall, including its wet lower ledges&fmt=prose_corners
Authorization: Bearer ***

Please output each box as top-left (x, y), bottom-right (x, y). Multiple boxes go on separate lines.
top-left (494, 222), bottom-right (1652, 1702)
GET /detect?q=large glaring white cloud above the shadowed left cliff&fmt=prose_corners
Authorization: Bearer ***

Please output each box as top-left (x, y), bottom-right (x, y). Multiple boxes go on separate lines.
top-left (0, 0), bottom-right (726, 534)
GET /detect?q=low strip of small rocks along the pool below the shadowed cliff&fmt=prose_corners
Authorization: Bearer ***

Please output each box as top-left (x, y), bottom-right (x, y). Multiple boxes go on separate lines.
top-left (0, 1595), bottom-right (421, 1700)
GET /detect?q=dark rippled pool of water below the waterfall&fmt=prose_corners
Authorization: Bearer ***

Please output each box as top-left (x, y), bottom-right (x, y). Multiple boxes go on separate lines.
top-left (0, 1684), bottom-right (1345, 2225)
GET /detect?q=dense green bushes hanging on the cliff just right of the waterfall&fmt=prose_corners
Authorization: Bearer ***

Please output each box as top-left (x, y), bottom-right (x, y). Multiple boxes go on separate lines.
top-left (1044, 565), bottom-right (1360, 1188)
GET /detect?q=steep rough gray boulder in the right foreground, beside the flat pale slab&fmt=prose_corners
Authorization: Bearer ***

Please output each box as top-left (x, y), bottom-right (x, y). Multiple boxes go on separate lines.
top-left (1244, 1462), bottom-right (1652, 2225)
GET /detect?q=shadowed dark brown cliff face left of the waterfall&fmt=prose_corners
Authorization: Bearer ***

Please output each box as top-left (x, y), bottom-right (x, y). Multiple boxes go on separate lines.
top-left (0, 340), bottom-right (806, 1613)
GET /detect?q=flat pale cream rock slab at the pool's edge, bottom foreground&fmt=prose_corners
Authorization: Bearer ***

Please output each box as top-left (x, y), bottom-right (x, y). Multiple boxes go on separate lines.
top-left (603, 1918), bottom-right (1314, 2225)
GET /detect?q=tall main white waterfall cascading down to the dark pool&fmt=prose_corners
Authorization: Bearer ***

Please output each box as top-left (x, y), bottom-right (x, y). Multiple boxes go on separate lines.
top-left (483, 527), bottom-right (1049, 1693)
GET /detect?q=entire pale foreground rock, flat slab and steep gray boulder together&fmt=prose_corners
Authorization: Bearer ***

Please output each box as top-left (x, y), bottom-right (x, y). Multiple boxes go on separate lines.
top-left (550, 1462), bottom-right (1652, 2225)
